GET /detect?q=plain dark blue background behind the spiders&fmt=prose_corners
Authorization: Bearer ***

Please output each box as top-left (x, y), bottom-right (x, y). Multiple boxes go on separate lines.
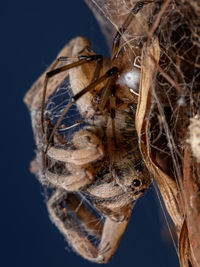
top-left (0, 0), bottom-right (178, 267)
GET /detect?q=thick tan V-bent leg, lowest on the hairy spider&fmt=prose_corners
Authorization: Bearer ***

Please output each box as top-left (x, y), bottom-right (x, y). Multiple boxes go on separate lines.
top-left (47, 190), bottom-right (128, 263)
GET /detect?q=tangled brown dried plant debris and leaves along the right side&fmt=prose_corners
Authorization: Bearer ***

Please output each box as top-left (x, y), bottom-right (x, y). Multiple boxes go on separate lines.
top-left (136, 1), bottom-right (200, 266)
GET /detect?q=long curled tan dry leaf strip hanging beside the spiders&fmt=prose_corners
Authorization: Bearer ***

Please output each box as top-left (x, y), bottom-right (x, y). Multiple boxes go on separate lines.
top-left (135, 39), bottom-right (183, 233)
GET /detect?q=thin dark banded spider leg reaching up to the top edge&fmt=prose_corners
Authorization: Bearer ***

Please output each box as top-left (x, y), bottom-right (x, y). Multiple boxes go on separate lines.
top-left (112, 1), bottom-right (153, 60)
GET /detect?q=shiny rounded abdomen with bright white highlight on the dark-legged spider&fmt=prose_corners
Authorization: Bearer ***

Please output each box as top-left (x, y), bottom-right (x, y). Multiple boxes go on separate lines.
top-left (117, 68), bottom-right (140, 95)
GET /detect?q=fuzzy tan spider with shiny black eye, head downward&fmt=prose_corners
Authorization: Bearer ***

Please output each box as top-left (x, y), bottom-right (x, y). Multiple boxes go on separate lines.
top-left (45, 99), bottom-right (151, 263)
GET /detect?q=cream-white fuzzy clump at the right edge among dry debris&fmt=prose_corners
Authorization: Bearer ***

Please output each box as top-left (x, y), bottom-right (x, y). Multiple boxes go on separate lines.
top-left (188, 115), bottom-right (200, 162)
